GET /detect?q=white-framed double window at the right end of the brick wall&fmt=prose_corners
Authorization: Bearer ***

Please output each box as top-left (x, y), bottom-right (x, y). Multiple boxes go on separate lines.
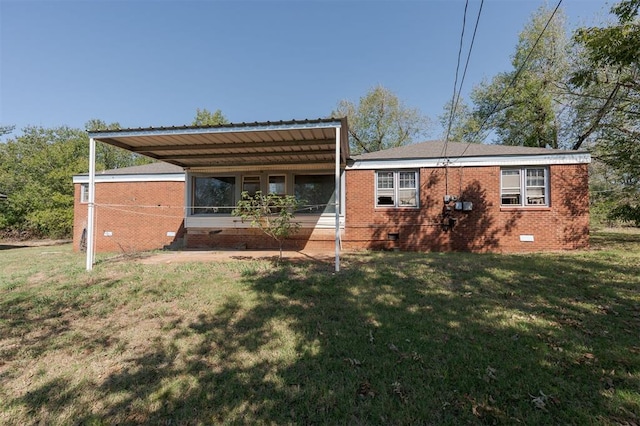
top-left (500, 167), bottom-right (549, 206)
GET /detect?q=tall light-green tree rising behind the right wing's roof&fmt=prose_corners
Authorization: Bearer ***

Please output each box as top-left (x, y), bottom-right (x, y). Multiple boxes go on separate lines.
top-left (464, 6), bottom-right (569, 148)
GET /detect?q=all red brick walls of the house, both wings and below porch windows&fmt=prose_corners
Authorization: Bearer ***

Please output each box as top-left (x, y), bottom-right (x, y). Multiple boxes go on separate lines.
top-left (74, 164), bottom-right (589, 252)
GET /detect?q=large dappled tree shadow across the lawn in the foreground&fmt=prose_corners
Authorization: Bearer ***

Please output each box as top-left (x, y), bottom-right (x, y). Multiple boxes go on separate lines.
top-left (6, 253), bottom-right (640, 424)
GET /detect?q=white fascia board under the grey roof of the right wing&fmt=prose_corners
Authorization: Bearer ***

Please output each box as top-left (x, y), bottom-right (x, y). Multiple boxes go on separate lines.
top-left (347, 153), bottom-right (591, 170)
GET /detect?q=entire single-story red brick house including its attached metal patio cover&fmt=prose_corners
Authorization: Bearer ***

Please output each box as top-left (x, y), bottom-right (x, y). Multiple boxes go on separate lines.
top-left (74, 119), bottom-right (590, 266)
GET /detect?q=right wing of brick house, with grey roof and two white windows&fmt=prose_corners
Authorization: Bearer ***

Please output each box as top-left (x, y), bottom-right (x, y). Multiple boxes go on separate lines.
top-left (344, 141), bottom-right (590, 252)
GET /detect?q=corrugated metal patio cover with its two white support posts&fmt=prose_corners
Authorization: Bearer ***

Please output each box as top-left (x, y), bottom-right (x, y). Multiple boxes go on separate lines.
top-left (86, 118), bottom-right (349, 271)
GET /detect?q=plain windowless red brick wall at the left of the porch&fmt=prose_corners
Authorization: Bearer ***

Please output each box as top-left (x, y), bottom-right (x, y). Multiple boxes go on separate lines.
top-left (73, 182), bottom-right (184, 253)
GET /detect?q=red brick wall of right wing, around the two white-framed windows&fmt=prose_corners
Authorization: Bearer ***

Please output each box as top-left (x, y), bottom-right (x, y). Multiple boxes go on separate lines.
top-left (343, 164), bottom-right (589, 252)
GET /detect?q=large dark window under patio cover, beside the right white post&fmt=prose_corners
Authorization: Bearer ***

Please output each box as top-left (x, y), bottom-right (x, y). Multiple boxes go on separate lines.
top-left (293, 175), bottom-right (336, 213)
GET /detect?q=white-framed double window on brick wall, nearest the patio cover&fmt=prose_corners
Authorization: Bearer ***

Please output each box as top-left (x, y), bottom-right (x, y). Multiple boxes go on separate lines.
top-left (376, 171), bottom-right (418, 207)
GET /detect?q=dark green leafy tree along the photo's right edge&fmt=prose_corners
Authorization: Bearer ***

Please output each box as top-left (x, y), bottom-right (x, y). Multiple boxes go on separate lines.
top-left (571, 0), bottom-right (640, 226)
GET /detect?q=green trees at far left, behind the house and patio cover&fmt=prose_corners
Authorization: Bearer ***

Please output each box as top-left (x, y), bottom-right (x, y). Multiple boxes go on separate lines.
top-left (0, 120), bottom-right (149, 238)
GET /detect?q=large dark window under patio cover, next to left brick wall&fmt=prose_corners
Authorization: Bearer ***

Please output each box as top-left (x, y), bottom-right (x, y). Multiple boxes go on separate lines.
top-left (192, 177), bottom-right (236, 214)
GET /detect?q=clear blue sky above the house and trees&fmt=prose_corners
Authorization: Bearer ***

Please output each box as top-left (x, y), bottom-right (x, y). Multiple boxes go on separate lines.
top-left (0, 0), bottom-right (611, 137)
